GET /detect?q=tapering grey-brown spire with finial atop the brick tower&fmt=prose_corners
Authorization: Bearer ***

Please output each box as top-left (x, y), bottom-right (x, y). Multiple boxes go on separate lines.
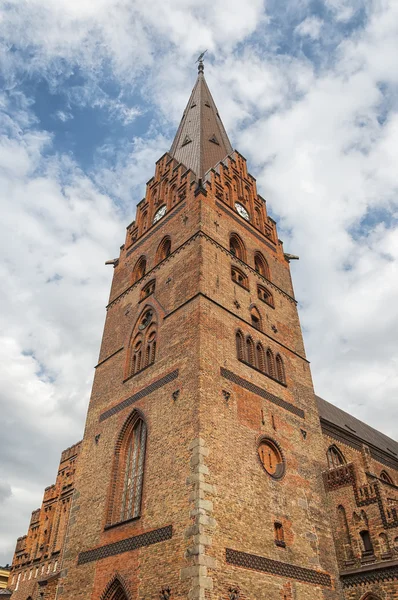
top-left (169, 55), bottom-right (233, 179)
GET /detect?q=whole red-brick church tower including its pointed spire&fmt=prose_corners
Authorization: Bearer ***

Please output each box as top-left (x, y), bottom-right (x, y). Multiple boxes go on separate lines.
top-left (56, 62), bottom-right (342, 600)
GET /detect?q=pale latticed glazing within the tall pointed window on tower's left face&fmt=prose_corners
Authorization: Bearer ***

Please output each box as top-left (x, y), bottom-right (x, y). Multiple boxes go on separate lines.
top-left (119, 419), bottom-right (146, 521)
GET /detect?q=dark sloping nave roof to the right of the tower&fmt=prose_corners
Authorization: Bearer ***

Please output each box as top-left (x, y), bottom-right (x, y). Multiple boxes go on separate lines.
top-left (315, 396), bottom-right (398, 460)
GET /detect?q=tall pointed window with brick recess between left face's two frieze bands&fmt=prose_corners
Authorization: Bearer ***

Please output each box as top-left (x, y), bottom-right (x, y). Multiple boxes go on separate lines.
top-left (107, 411), bottom-right (146, 525)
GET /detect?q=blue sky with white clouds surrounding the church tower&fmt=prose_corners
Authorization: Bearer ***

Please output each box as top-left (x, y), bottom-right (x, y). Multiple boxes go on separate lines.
top-left (0, 0), bottom-right (398, 564)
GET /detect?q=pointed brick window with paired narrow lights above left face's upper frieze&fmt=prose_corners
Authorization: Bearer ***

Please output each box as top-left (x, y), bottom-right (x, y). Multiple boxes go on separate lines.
top-left (124, 306), bottom-right (157, 379)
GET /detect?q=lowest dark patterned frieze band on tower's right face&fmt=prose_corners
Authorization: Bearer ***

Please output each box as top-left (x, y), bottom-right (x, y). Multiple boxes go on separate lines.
top-left (226, 548), bottom-right (332, 587)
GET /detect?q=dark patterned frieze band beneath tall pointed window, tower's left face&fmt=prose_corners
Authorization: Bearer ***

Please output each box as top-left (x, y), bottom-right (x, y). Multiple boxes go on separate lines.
top-left (77, 525), bottom-right (173, 565)
